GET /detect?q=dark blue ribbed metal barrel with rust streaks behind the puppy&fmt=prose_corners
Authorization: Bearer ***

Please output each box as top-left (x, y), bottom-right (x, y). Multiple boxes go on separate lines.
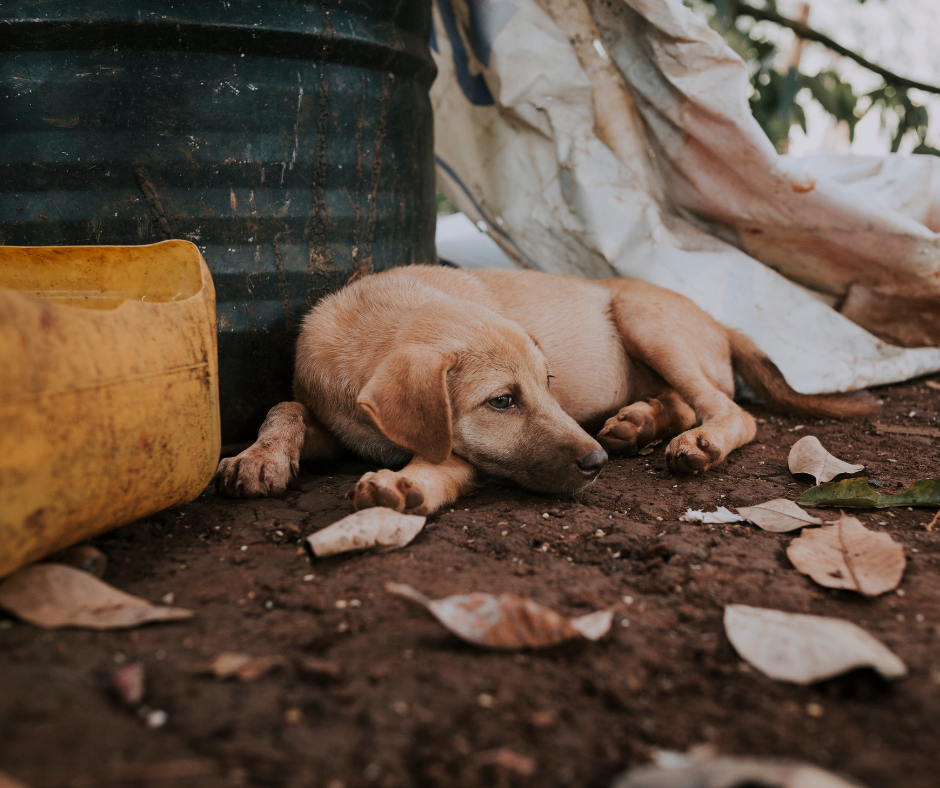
top-left (0, 0), bottom-right (436, 443)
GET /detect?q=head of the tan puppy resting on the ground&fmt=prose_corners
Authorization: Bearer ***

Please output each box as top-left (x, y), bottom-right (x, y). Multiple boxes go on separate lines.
top-left (358, 310), bottom-right (607, 493)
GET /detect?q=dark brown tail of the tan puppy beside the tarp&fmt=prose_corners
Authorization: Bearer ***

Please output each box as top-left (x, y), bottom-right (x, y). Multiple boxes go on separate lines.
top-left (728, 329), bottom-right (875, 419)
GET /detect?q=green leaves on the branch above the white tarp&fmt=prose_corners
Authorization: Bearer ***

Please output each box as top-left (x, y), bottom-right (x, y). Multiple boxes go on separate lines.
top-left (685, 0), bottom-right (940, 155)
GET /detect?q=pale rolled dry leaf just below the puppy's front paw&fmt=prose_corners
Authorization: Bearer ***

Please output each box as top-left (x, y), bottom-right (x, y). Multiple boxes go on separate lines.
top-left (307, 506), bottom-right (427, 558)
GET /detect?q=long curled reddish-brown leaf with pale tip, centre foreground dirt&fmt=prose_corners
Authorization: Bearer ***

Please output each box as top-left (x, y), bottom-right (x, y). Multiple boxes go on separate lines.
top-left (385, 583), bottom-right (614, 649)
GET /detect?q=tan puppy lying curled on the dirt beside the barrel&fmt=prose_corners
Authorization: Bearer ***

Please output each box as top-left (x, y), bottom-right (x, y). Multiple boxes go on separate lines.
top-left (215, 266), bottom-right (870, 514)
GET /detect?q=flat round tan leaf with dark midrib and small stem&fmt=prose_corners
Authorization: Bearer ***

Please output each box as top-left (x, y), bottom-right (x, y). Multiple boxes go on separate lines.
top-left (787, 514), bottom-right (906, 596)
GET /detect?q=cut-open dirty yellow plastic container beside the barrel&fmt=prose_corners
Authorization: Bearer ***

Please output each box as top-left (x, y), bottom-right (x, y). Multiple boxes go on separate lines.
top-left (0, 241), bottom-right (220, 577)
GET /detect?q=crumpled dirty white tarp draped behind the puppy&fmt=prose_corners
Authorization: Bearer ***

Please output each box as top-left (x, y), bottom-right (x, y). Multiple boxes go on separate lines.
top-left (431, 0), bottom-right (940, 393)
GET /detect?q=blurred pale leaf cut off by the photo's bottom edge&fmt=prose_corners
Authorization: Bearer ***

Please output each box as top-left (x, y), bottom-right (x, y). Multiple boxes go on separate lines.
top-left (613, 757), bottom-right (858, 788)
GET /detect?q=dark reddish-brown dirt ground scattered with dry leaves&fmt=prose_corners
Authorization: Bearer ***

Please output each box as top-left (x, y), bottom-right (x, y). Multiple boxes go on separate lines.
top-left (0, 380), bottom-right (940, 788)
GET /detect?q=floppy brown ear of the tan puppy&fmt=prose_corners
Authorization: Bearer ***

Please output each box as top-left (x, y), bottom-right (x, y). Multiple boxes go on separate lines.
top-left (356, 346), bottom-right (456, 463)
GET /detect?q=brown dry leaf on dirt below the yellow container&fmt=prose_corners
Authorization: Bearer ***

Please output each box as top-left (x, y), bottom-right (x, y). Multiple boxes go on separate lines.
top-left (0, 564), bottom-right (193, 629)
